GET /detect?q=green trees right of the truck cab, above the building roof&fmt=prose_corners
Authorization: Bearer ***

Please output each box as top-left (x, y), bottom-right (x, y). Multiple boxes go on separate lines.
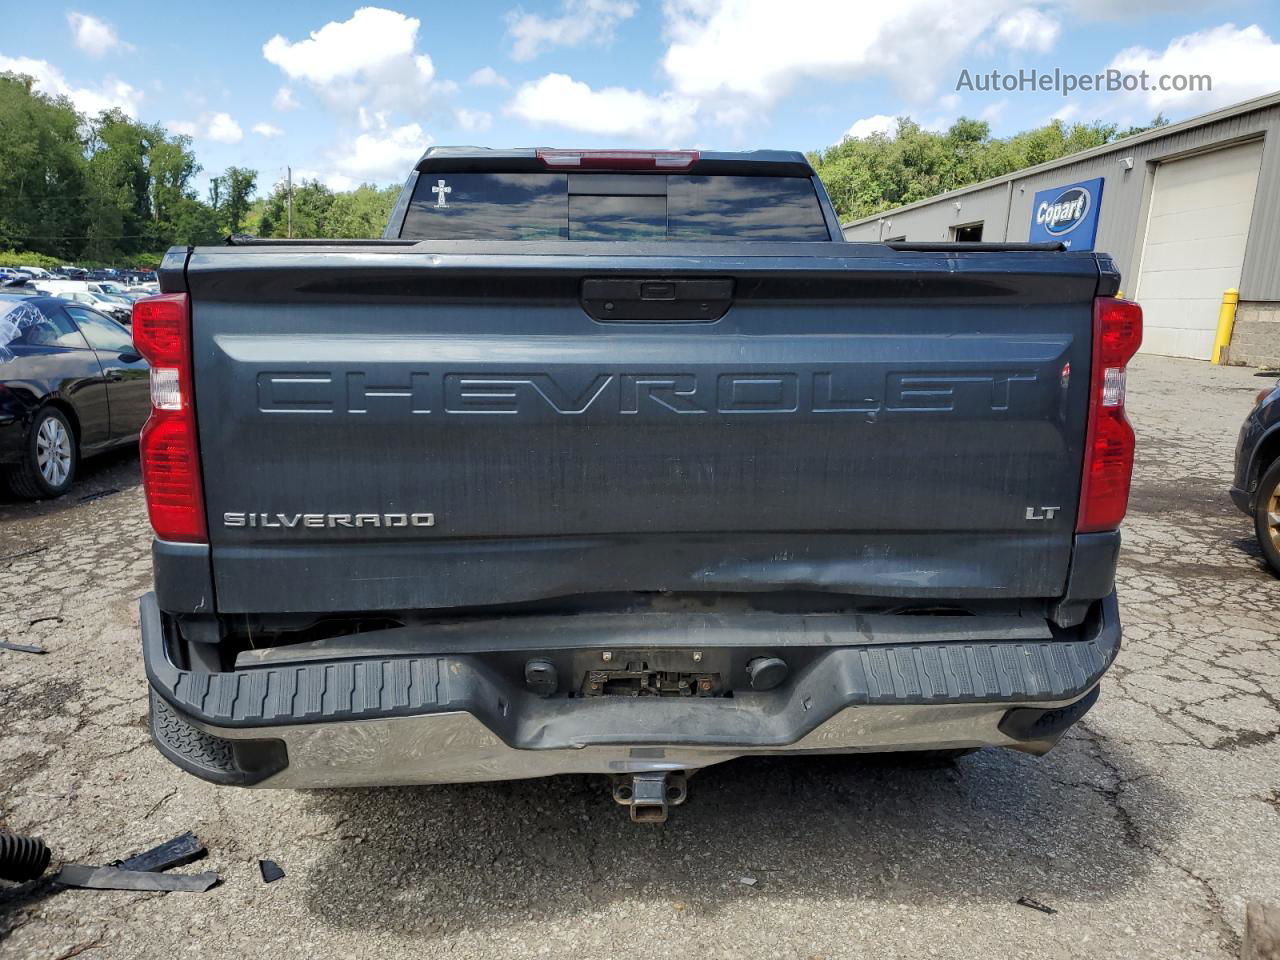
top-left (809, 115), bottom-right (1169, 220)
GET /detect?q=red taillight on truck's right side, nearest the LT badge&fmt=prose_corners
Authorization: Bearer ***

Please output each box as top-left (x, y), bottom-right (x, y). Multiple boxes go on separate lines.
top-left (1075, 297), bottom-right (1142, 534)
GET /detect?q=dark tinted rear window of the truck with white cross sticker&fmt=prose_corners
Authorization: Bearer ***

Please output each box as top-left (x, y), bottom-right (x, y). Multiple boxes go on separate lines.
top-left (401, 173), bottom-right (831, 241)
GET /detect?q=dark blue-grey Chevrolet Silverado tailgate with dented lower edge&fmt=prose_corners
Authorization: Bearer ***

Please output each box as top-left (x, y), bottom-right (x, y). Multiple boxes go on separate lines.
top-left (170, 242), bottom-right (1098, 613)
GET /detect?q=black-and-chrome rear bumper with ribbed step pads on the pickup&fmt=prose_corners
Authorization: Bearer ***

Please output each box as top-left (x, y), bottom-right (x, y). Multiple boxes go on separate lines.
top-left (141, 594), bottom-right (1120, 787)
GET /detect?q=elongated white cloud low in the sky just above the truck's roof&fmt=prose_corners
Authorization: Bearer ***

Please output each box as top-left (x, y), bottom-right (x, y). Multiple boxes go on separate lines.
top-left (507, 73), bottom-right (698, 143)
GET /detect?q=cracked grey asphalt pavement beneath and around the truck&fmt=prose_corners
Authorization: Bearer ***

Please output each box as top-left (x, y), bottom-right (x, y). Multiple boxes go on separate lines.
top-left (0, 357), bottom-right (1280, 960)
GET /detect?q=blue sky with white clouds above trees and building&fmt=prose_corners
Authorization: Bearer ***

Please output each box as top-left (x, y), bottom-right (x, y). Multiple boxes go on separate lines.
top-left (0, 0), bottom-right (1280, 197)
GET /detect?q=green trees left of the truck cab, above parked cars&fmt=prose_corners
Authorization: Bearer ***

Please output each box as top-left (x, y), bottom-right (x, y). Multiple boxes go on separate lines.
top-left (0, 73), bottom-right (398, 266)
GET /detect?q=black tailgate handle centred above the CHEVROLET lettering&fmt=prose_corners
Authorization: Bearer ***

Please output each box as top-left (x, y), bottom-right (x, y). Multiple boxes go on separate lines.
top-left (581, 276), bottom-right (733, 324)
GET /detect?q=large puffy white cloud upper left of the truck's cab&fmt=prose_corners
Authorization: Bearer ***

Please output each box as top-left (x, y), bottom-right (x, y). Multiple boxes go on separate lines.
top-left (262, 6), bottom-right (439, 110)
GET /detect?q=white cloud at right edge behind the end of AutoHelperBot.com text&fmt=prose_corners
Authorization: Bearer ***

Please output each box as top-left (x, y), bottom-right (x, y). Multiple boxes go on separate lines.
top-left (1107, 23), bottom-right (1280, 114)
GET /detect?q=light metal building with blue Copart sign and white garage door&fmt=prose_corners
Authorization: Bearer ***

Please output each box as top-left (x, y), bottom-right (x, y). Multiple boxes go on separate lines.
top-left (845, 92), bottom-right (1280, 366)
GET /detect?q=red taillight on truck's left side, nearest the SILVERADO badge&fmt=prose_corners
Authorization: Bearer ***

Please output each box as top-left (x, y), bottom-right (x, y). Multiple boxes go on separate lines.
top-left (133, 293), bottom-right (209, 543)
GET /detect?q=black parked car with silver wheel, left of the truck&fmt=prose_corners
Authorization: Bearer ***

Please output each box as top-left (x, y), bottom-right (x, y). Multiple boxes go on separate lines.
top-left (0, 293), bottom-right (151, 498)
